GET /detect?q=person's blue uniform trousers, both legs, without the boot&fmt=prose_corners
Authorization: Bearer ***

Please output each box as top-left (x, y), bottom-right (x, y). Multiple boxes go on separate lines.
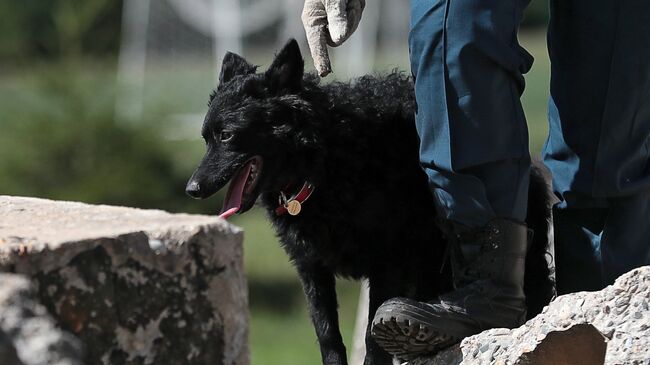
top-left (409, 0), bottom-right (650, 291)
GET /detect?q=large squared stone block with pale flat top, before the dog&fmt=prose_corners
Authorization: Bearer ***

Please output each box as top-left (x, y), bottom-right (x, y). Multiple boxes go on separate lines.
top-left (0, 196), bottom-right (249, 365)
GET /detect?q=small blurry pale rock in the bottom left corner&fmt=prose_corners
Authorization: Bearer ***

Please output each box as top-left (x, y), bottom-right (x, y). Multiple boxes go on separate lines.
top-left (0, 274), bottom-right (82, 365)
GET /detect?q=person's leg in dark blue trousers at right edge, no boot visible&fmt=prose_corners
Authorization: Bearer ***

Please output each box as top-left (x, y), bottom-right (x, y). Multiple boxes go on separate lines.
top-left (543, 0), bottom-right (650, 294)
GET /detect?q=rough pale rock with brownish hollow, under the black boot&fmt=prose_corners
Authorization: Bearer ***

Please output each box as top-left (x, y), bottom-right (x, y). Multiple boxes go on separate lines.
top-left (416, 266), bottom-right (650, 365)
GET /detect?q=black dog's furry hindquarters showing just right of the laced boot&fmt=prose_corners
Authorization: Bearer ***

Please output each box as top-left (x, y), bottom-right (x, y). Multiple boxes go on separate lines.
top-left (524, 161), bottom-right (556, 318)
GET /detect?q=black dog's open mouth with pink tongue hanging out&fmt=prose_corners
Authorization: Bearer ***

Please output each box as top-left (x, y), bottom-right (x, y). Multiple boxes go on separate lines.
top-left (219, 156), bottom-right (262, 219)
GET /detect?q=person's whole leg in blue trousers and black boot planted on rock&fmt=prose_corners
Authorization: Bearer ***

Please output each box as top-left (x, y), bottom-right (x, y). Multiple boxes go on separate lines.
top-left (372, 0), bottom-right (532, 358)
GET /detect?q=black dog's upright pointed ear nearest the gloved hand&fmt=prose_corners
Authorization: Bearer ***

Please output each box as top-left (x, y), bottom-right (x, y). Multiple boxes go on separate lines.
top-left (265, 39), bottom-right (305, 92)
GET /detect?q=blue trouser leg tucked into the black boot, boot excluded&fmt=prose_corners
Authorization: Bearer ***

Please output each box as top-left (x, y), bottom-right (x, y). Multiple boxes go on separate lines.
top-left (409, 0), bottom-right (532, 228)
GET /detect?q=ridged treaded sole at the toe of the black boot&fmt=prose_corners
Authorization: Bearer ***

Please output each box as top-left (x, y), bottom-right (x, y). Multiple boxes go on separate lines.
top-left (371, 303), bottom-right (463, 361)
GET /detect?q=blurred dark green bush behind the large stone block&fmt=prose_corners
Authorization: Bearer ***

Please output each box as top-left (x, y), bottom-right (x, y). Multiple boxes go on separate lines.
top-left (0, 64), bottom-right (214, 212)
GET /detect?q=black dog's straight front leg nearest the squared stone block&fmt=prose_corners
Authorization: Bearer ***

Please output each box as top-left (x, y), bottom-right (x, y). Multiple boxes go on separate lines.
top-left (298, 264), bottom-right (347, 365)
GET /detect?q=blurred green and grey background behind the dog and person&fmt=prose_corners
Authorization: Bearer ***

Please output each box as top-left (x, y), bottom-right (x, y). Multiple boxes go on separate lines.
top-left (0, 0), bottom-right (549, 365)
